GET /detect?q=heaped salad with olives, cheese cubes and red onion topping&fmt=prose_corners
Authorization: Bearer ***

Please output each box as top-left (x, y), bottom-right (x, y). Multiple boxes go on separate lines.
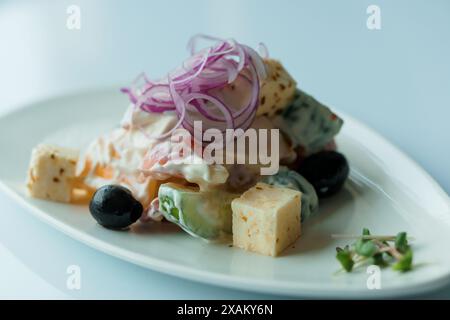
top-left (27, 35), bottom-right (349, 256)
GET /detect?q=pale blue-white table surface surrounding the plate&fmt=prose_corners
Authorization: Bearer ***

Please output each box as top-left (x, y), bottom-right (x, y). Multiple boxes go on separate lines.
top-left (0, 0), bottom-right (450, 299)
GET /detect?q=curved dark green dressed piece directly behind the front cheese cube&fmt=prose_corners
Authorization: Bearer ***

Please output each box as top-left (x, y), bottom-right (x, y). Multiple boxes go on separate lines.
top-left (262, 166), bottom-right (319, 221)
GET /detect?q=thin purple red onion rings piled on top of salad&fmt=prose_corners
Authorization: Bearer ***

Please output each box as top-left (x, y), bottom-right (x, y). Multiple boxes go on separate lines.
top-left (121, 35), bottom-right (268, 137)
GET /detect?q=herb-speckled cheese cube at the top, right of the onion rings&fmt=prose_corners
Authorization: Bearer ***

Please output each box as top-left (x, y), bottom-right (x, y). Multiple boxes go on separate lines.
top-left (256, 59), bottom-right (297, 117)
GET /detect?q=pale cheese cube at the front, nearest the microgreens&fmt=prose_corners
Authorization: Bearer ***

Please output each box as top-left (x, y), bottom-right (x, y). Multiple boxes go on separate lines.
top-left (231, 183), bottom-right (301, 256)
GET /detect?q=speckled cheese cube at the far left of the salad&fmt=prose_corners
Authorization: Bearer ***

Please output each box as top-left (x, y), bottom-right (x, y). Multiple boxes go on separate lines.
top-left (27, 144), bottom-right (78, 202)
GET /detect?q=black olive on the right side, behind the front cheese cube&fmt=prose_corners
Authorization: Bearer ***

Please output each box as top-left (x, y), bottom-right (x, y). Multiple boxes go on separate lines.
top-left (298, 151), bottom-right (350, 198)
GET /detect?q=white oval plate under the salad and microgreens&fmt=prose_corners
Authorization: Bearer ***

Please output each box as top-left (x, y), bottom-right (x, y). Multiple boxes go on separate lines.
top-left (0, 90), bottom-right (450, 298)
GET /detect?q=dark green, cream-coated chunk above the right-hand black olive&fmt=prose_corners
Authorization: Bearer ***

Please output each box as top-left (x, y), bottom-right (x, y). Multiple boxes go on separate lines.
top-left (273, 89), bottom-right (343, 154)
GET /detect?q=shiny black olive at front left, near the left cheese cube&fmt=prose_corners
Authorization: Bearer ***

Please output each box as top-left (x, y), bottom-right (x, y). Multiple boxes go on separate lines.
top-left (89, 185), bottom-right (143, 229)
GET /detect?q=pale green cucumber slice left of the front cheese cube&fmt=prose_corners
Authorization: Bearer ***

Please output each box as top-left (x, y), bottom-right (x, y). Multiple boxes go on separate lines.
top-left (158, 183), bottom-right (238, 240)
